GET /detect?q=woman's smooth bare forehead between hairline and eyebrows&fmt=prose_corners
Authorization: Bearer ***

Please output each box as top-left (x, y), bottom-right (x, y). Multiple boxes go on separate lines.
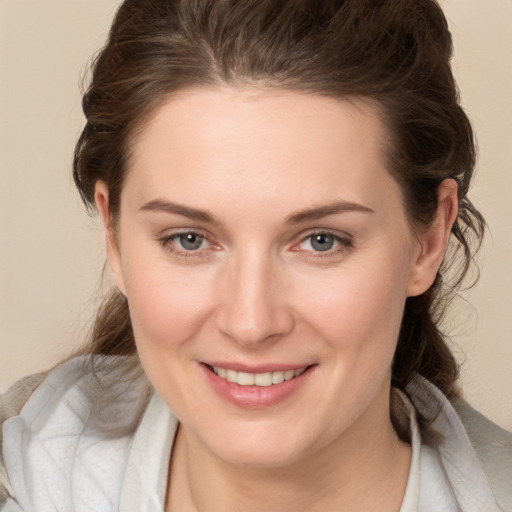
top-left (123, 88), bottom-right (400, 216)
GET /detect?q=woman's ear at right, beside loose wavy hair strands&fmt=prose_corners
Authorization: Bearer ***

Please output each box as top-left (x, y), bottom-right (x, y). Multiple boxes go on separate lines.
top-left (407, 179), bottom-right (458, 297)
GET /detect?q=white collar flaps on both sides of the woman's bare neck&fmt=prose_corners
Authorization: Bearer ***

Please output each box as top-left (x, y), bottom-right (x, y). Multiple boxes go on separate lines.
top-left (120, 377), bottom-right (500, 512)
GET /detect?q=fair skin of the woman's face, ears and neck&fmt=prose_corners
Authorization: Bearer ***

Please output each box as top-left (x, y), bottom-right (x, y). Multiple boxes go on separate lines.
top-left (96, 88), bottom-right (456, 511)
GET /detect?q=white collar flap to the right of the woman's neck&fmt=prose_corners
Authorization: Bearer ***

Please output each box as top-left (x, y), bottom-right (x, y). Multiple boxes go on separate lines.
top-left (400, 376), bottom-right (501, 512)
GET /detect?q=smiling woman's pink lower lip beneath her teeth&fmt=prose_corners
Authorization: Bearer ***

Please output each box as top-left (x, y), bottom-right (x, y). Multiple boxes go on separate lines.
top-left (199, 364), bottom-right (314, 409)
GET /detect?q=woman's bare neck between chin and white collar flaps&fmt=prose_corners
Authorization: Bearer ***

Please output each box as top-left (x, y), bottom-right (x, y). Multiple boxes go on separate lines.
top-left (167, 386), bottom-right (411, 512)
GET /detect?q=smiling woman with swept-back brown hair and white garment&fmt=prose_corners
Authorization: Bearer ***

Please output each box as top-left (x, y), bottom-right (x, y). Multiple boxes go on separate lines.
top-left (0, 0), bottom-right (512, 512)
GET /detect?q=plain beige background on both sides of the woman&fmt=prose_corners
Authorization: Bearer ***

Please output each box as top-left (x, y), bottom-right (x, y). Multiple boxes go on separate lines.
top-left (0, 0), bottom-right (512, 429)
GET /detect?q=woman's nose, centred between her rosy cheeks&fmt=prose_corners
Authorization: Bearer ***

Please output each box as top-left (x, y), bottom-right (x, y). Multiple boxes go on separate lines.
top-left (217, 249), bottom-right (294, 348)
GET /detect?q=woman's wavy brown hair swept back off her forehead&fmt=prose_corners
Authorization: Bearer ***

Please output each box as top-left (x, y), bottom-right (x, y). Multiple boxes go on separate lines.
top-left (74, 0), bottom-right (485, 397)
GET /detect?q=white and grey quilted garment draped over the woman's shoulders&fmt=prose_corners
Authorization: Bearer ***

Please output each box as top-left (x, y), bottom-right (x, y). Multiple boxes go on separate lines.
top-left (0, 358), bottom-right (512, 512)
